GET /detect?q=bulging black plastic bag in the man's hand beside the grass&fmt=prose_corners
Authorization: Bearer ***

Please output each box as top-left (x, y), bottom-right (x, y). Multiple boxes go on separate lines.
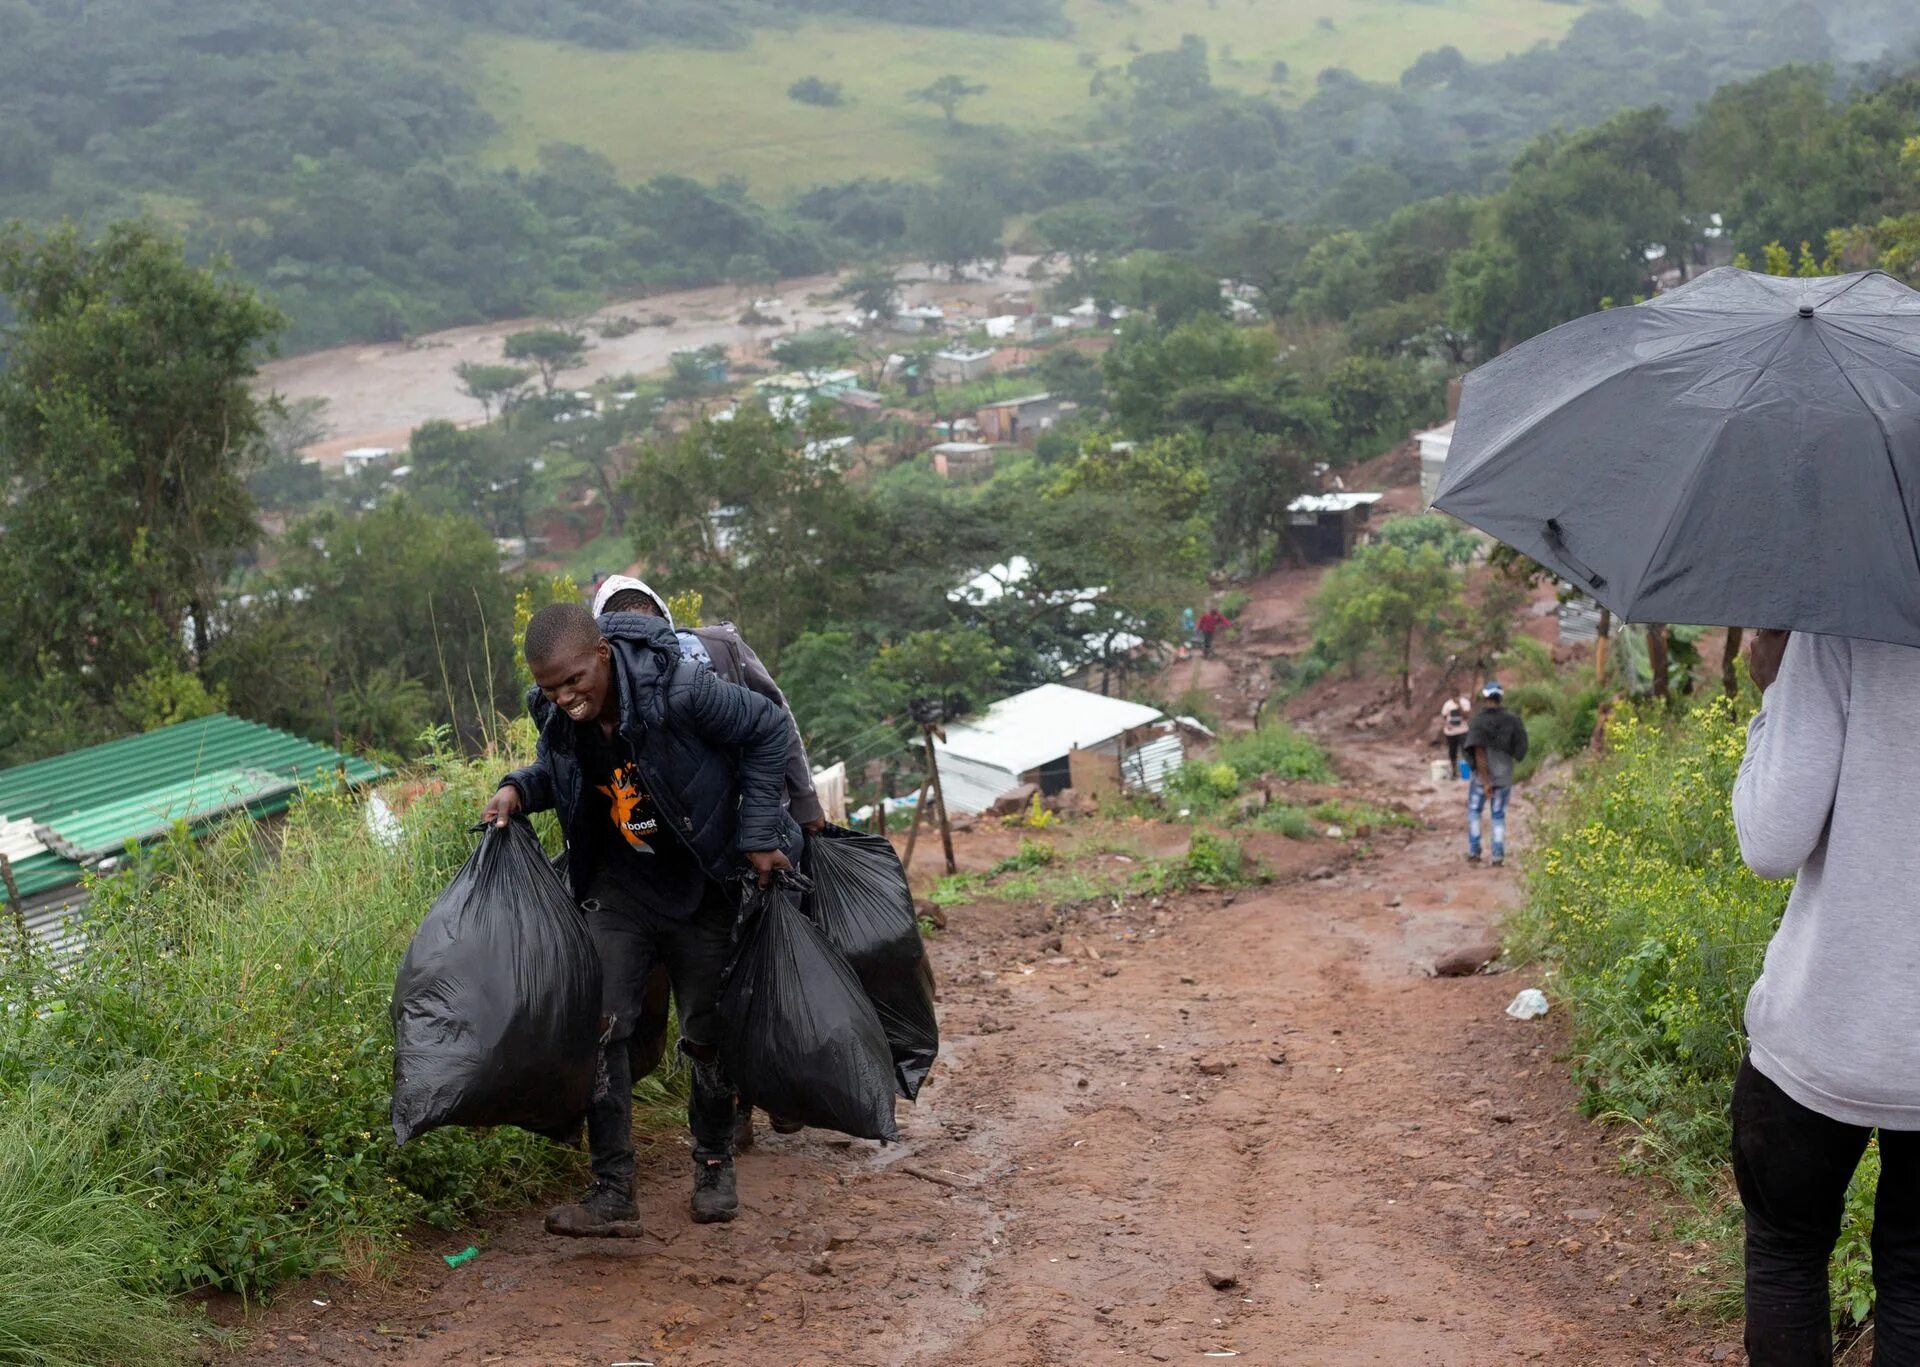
top-left (394, 820), bottom-right (601, 1144)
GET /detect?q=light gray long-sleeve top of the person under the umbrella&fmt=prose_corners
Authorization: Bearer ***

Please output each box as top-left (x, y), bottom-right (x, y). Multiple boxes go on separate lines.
top-left (1734, 634), bottom-right (1920, 1129)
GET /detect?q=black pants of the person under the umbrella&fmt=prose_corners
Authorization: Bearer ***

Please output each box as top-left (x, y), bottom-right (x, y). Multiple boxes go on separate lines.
top-left (1734, 1060), bottom-right (1920, 1367)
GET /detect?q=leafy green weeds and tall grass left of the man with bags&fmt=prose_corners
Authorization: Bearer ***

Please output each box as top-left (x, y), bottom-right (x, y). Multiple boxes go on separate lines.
top-left (0, 748), bottom-right (674, 1294)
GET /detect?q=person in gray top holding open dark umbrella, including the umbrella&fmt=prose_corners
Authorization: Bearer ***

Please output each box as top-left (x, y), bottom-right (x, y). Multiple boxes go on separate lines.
top-left (1434, 267), bottom-right (1920, 1367)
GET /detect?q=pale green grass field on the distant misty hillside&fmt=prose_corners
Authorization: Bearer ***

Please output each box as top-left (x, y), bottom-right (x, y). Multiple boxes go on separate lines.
top-left (467, 0), bottom-right (1612, 194)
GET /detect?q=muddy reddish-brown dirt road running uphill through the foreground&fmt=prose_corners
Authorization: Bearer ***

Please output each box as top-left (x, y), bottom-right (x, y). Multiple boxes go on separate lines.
top-left (238, 741), bottom-right (1738, 1367)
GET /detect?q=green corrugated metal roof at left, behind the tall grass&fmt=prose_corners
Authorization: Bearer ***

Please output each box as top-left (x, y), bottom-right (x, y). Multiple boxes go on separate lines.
top-left (0, 714), bottom-right (386, 897)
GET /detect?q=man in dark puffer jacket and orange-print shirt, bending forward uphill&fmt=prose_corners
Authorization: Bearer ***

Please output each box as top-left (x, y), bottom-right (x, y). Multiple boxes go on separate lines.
top-left (484, 603), bottom-right (801, 1236)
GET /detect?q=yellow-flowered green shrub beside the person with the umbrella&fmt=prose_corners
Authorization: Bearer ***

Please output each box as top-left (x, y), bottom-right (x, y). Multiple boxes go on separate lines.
top-left (1509, 697), bottom-right (1876, 1317)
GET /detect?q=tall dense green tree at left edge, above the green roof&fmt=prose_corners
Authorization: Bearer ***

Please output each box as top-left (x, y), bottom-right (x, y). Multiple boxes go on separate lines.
top-left (0, 225), bottom-right (280, 701)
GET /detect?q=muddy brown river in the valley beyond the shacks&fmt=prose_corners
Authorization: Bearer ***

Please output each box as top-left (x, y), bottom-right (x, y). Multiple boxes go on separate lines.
top-left (259, 257), bottom-right (1033, 465)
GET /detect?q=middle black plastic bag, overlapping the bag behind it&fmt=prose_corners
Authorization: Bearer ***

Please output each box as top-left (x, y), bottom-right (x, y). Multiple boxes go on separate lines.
top-left (720, 883), bottom-right (900, 1140)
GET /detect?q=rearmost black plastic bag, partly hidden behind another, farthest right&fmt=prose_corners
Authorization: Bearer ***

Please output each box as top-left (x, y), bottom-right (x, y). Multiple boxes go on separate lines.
top-left (804, 826), bottom-right (941, 1100)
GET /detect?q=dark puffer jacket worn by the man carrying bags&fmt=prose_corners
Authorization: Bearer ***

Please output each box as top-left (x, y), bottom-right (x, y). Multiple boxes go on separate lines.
top-left (501, 612), bottom-right (801, 893)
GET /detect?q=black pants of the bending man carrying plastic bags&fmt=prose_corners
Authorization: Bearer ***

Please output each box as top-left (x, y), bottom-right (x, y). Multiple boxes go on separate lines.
top-left (582, 877), bottom-right (733, 1185)
